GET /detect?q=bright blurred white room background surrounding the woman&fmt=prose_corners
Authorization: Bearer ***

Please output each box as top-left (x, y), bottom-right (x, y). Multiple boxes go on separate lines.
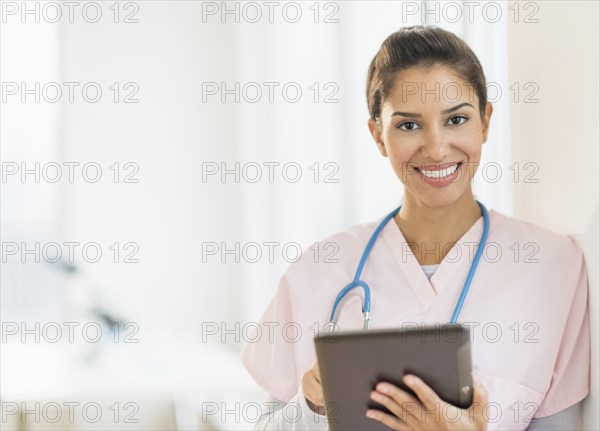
top-left (0, 1), bottom-right (600, 430)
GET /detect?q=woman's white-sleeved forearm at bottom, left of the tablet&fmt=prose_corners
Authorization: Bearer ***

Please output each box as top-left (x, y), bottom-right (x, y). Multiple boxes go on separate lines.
top-left (254, 385), bottom-right (329, 431)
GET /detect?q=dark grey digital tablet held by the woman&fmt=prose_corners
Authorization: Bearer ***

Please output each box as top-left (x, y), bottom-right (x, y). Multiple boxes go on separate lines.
top-left (315, 324), bottom-right (473, 431)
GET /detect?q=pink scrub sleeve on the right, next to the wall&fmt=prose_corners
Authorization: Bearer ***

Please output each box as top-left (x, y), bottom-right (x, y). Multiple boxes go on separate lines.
top-left (534, 247), bottom-right (590, 418)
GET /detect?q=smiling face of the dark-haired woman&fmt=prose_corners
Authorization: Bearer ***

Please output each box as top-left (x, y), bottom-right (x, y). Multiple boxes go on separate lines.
top-left (369, 65), bottom-right (493, 211)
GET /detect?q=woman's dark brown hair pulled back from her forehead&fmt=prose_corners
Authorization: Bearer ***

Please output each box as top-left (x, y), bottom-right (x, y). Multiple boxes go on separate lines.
top-left (367, 25), bottom-right (487, 120)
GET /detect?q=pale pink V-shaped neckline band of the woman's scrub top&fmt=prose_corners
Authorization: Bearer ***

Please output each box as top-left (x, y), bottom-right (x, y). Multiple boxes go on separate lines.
top-left (381, 210), bottom-right (494, 312)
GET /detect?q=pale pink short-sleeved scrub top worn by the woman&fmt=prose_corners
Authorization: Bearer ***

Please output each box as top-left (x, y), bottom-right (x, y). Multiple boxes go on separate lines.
top-left (241, 210), bottom-right (590, 430)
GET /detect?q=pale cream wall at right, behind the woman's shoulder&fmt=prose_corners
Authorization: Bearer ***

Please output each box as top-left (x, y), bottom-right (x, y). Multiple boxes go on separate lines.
top-left (509, 1), bottom-right (600, 429)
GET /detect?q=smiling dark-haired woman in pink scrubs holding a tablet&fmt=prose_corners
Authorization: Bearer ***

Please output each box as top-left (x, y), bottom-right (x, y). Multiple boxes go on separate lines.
top-left (242, 26), bottom-right (590, 430)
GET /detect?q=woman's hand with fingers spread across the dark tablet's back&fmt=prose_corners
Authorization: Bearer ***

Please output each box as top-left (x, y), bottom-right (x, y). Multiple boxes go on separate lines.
top-left (367, 374), bottom-right (487, 430)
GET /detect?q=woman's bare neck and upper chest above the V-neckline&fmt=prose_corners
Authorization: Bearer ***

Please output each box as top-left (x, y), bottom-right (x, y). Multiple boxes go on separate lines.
top-left (395, 193), bottom-right (481, 265)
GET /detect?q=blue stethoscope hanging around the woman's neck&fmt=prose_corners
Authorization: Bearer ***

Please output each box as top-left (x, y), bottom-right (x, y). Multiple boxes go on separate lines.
top-left (326, 200), bottom-right (490, 332)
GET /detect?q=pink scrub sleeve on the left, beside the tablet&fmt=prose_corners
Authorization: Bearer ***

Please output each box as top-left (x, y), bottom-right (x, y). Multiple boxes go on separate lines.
top-left (241, 275), bottom-right (299, 402)
